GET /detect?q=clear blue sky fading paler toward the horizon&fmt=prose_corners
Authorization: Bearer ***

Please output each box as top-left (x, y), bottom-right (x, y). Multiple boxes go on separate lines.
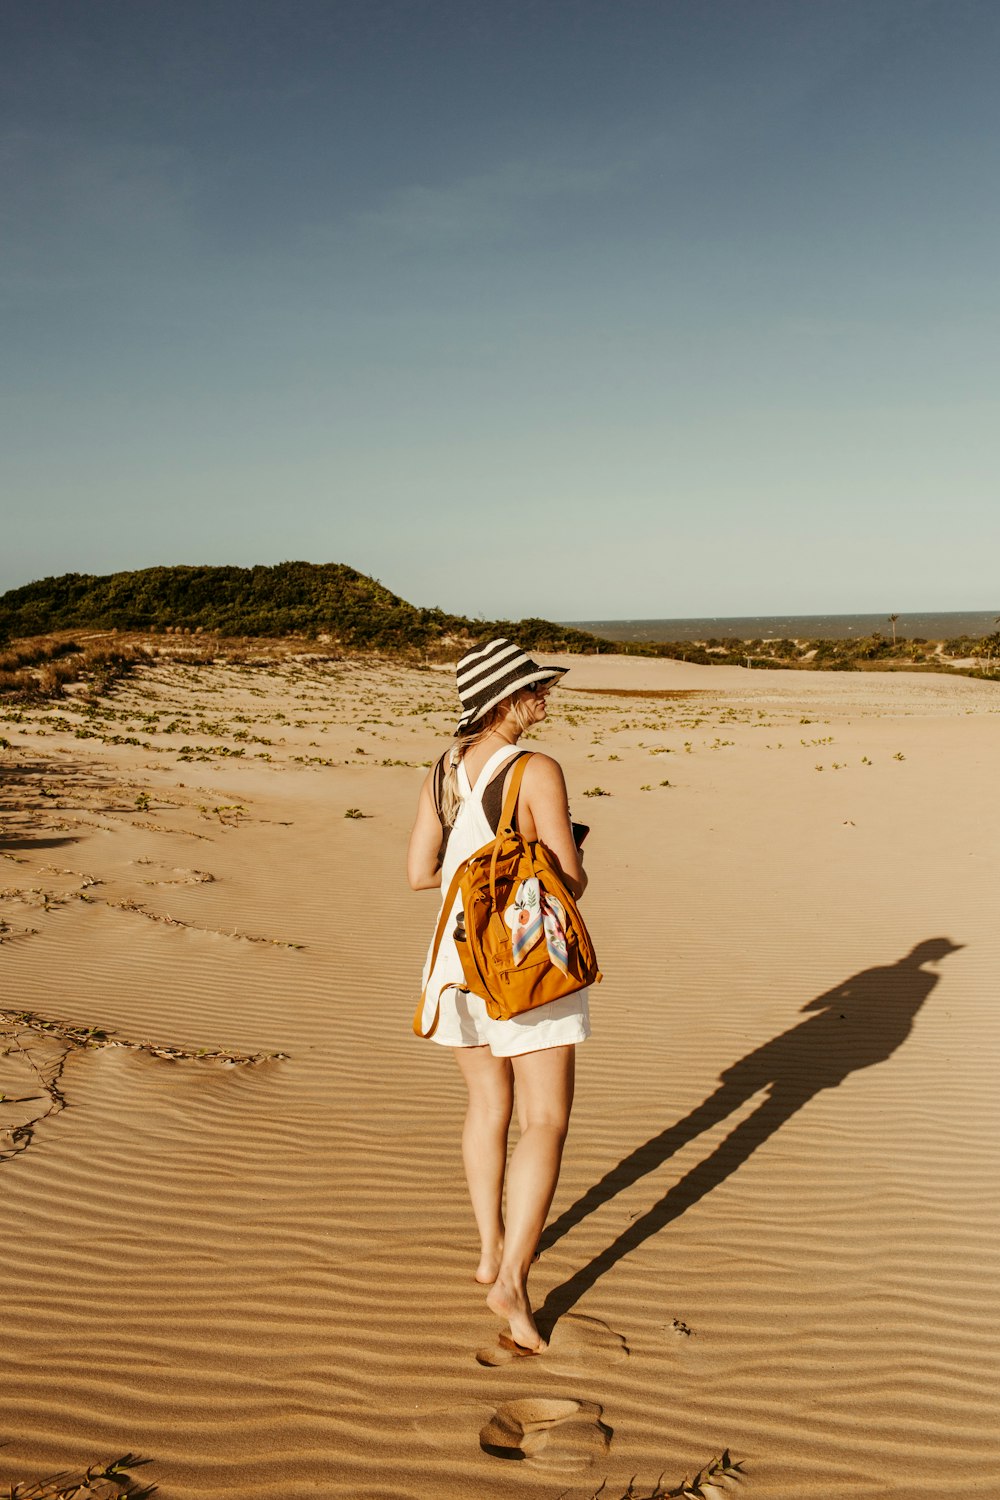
top-left (0, 0), bottom-right (1000, 620)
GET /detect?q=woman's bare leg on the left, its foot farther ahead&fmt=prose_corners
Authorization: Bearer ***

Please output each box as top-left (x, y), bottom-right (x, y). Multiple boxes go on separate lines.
top-left (456, 1047), bottom-right (514, 1286)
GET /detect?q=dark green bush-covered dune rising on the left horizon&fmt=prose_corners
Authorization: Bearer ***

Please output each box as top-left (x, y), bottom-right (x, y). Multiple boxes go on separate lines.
top-left (0, 563), bottom-right (616, 651)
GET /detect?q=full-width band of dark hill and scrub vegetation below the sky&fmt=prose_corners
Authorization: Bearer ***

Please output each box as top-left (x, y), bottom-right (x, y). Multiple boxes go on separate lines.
top-left (0, 563), bottom-right (1000, 696)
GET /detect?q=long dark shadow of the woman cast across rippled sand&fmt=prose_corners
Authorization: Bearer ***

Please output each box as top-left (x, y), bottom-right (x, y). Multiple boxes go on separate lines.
top-left (535, 938), bottom-right (963, 1337)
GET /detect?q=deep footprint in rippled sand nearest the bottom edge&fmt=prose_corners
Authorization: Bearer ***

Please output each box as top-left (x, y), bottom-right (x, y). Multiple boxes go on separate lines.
top-left (480, 1397), bottom-right (612, 1470)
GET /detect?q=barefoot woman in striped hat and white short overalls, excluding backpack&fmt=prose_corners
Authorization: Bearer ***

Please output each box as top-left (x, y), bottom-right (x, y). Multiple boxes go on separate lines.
top-left (406, 639), bottom-right (591, 1353)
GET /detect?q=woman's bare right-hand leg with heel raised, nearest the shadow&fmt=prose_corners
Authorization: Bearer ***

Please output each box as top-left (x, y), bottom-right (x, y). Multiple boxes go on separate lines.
top-left (486, 1047), bottom-right (576, 1349)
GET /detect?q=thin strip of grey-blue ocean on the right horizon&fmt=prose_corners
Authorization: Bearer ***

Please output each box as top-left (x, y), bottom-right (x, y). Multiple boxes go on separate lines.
top-left (561, 609), bottom-right (1000, 641)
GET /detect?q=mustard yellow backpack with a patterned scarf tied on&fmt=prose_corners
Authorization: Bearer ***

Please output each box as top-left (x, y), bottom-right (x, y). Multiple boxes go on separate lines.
top-left (414, 756), bottom-right (601, 1037)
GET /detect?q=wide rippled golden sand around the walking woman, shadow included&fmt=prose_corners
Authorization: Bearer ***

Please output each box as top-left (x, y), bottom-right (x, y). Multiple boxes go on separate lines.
top-left (0, 656), bottom-right (1000, 1500)
